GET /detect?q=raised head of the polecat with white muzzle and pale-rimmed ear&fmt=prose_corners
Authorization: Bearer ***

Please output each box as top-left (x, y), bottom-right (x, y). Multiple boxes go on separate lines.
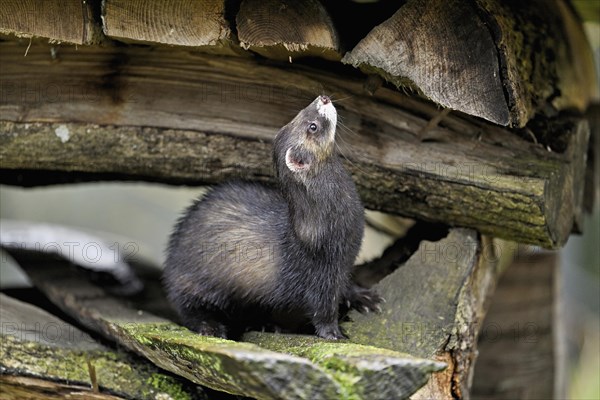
top-left (274, 96), bottom-right (337, 181)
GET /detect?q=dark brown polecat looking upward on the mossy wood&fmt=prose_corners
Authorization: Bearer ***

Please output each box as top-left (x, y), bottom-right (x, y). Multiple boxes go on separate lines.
top-left (163, 96), bottom-right (381, 339)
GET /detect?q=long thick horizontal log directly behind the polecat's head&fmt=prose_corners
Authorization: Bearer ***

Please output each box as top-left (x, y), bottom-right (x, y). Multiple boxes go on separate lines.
top-left (0, 42), bottom-right (588, 247)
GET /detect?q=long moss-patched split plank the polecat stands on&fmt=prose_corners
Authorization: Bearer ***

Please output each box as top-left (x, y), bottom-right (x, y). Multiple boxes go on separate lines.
top-left (11, 252), bottom-right (445, 399)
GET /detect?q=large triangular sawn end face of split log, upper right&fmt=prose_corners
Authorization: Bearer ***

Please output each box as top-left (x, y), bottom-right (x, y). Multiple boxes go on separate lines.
top-left (342, 0), bottom-right (510, 125)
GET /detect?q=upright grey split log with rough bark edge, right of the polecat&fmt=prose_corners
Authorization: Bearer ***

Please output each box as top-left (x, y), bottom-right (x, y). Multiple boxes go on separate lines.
top-left (343, 229), bottom-right (516, 399)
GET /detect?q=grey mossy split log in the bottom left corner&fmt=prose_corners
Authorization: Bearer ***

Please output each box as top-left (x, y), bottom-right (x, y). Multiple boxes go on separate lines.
top-left (0, 294), bottom-right (205, 400)
